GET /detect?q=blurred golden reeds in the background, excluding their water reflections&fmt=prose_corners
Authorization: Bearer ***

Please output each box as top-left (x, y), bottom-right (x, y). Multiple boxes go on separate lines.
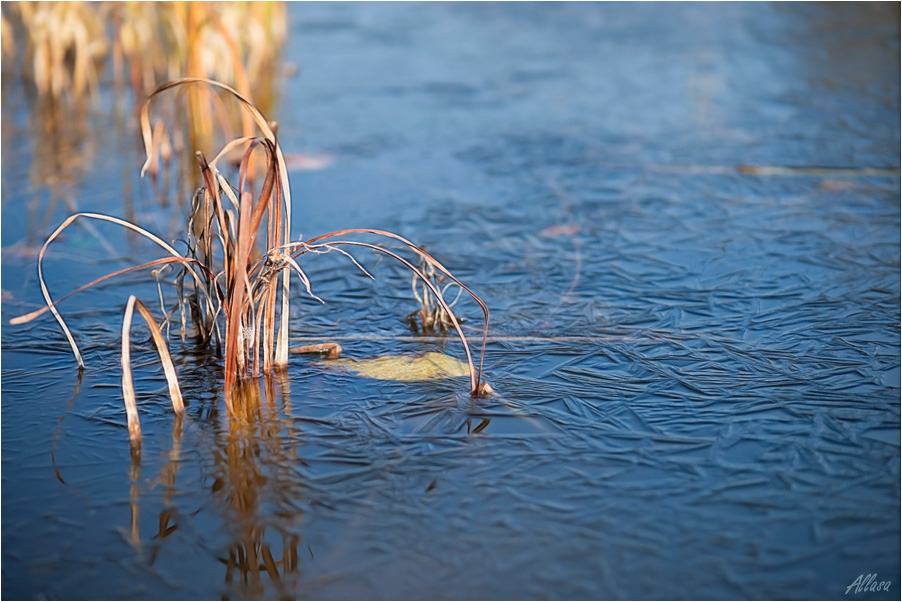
top-left (2, 2), bottom-right (285, 110)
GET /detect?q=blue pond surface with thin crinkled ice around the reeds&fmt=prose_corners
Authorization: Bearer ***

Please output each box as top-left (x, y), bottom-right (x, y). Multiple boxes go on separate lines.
top-left (2, 3), bottom-right (900, 599)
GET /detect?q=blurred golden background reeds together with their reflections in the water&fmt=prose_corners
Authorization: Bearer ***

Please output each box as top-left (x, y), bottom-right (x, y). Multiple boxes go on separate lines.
top-left (0, 2), bottom-right (286, 205)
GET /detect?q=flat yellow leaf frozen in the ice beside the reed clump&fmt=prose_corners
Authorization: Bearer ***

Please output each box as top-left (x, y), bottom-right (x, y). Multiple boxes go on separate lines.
top-left (321, 352), bottom-right (470, 382)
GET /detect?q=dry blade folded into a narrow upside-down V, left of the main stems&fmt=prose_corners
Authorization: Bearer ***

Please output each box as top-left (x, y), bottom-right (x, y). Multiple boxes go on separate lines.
top-left (121, 295), bottom-right (185, 443)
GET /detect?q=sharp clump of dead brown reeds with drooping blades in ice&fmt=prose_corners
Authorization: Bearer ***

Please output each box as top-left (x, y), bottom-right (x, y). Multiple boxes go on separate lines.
top-left (12, 78), bottom-right (491, 442)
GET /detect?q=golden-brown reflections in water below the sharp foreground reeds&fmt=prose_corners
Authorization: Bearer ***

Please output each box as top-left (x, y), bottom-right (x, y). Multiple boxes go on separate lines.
top-left (129, 375), bottom-right (302, 599)
